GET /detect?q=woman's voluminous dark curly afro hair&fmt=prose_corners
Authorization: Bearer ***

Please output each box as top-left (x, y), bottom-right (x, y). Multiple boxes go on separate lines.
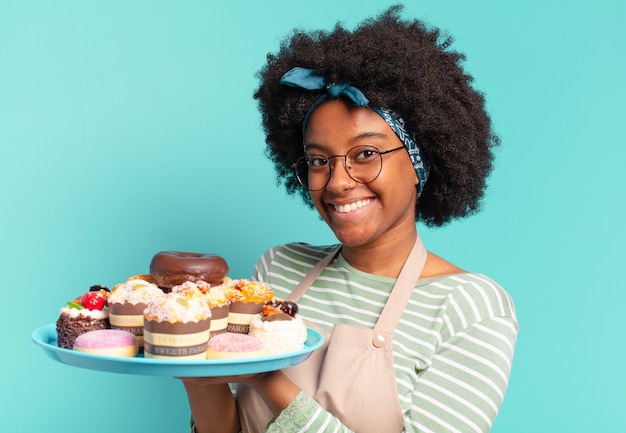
top-left (254, 5), bottom-right (499, 226)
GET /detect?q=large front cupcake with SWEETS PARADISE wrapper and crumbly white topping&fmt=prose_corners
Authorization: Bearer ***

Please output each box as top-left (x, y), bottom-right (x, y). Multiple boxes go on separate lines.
top-left (143, 289), bottom-right (211, 360)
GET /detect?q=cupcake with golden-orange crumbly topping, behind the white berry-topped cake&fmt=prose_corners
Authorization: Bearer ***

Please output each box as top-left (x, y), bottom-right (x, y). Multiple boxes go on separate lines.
top-left (226, 279), bottom-right (274, 334)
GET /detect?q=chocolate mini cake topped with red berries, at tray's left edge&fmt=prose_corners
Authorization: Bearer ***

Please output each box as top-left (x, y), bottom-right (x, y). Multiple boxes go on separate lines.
top-left (56, 285), bottom-right (109, 349)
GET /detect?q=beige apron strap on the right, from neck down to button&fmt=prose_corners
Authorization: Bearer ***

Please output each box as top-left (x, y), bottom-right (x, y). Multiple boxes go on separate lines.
top-left (374, 234), bottom-right (428, 332)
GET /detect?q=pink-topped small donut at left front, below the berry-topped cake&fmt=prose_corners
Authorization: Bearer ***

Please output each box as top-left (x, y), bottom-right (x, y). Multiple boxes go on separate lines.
top-left (74, 329), bottom-right (139, 357)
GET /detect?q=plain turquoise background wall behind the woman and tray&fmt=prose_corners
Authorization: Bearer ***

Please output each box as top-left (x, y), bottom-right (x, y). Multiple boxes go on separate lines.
top-left (0, 0), bottom-right (626, 433)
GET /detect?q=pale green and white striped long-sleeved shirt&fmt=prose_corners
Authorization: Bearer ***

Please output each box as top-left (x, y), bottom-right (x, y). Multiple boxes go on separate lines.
top-left (253, 243), bottom-right (518, 433)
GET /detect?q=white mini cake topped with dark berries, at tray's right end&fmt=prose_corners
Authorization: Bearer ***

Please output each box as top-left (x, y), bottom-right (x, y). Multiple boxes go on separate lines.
top-left (250, 298), bottom-right (307, 355)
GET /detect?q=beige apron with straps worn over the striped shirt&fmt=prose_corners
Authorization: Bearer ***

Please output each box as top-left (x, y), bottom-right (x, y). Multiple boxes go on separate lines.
top-left (238, 236), bottom-right (426, 433)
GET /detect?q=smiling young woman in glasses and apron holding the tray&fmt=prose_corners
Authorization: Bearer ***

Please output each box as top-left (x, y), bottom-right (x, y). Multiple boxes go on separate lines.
top-left (183, 6), bottom-right (518, 433)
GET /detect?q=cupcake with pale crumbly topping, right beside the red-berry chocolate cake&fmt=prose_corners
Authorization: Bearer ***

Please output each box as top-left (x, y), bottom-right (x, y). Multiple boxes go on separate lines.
top-left (107, 275), bottom-right (164, 347)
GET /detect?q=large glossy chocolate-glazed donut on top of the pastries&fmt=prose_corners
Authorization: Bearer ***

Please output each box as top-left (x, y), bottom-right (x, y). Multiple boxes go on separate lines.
top-left (150, 251), bottom-right (228, 291)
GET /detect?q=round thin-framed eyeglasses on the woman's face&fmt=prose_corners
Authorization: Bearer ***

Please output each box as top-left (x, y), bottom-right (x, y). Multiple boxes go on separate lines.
top-left (292, 146), bottom-right (405, 191)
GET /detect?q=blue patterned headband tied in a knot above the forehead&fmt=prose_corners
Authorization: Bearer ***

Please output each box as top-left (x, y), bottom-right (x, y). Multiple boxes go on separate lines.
top-left (280, 66), bottom-right (428, 196)
